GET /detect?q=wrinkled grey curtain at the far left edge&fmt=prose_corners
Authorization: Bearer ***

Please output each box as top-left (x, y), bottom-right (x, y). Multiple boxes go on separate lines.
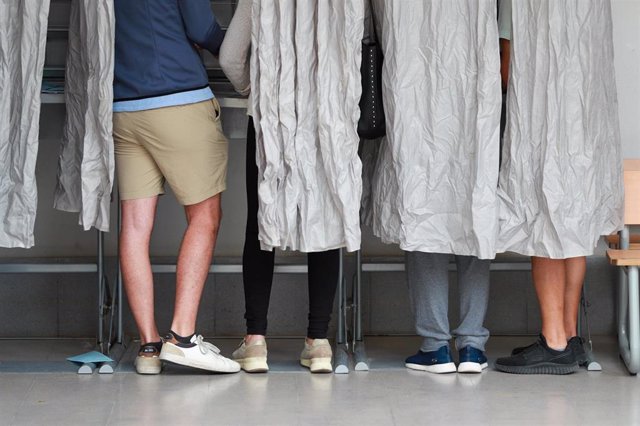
top-left (0, 0), bottom-right (49, 248)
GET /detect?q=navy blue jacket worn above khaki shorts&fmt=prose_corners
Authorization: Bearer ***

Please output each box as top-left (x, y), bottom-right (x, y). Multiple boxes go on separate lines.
top-left (114, 0), bottom-right (224, 101)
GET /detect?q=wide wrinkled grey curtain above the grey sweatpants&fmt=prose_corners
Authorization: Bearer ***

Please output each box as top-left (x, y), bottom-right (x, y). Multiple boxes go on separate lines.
top-left (369, 0), bottom-right (502, 259)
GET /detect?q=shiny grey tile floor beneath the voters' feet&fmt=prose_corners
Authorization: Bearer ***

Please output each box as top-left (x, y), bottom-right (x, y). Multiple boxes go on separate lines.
top-left (0, 337), bottom-right (640, 425)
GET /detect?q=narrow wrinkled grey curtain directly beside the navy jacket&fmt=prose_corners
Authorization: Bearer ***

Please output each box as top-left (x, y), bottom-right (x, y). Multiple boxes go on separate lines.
top-left (54, 0), bottom-right (115, 232)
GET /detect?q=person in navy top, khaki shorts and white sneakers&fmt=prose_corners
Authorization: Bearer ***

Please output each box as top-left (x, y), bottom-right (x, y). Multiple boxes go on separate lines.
top-left (113, 0), bottom-right (240, 374)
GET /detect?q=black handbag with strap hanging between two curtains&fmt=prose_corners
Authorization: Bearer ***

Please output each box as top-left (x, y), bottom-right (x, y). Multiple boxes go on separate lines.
top-left (358, 1), bottom-right (387, 139)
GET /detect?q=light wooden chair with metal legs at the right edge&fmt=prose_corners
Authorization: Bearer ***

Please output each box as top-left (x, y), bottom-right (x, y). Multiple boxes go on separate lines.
top-left (607, 159), bottom-right (640, 375)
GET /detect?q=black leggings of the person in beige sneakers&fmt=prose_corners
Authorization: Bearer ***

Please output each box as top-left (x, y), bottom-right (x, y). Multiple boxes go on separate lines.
top-left (242, 119), bottom-right (340, 339)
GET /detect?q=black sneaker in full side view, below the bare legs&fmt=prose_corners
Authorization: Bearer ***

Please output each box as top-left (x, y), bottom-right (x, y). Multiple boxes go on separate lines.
top-left (495, 334), bottom-right (578, 374)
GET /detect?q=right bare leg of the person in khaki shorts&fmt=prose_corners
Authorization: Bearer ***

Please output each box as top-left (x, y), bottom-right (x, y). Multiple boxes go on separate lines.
top-left (171, 194), bottom-right (222, 336)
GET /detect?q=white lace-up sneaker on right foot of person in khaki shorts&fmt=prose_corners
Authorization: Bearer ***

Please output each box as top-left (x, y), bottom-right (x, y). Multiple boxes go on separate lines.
top-left (160, 334), bottom-right (240, 373)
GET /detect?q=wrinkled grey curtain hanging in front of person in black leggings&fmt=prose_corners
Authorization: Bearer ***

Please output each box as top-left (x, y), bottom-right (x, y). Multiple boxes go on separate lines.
top-left (251, 0), bottom-right (364, 252)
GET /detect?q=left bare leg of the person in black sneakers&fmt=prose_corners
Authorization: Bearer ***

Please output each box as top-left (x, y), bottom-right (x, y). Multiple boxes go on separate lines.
top-left (531, 257), bottom-right (567, 350)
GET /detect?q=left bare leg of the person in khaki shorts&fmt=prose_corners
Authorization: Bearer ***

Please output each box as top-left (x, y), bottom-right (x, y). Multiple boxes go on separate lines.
top-left (120, 196), bottom-right (160, 344)
